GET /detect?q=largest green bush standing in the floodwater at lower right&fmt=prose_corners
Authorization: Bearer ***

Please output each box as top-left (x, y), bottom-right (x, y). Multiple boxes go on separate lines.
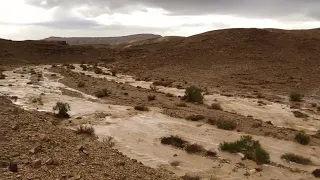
top-left (219, 136), bottom-right (270, 164)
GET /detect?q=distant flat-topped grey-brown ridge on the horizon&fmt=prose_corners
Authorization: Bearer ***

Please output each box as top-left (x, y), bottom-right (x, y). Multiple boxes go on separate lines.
top-left (44, 34), bottom-right (161, 45)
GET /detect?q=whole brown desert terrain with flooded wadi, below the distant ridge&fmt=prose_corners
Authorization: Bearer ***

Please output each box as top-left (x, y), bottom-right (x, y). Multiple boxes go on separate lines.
top-left (0, 29), bottom-right (320, 180)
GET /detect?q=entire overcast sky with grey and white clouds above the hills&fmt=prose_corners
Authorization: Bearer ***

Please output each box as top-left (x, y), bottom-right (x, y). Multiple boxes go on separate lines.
top-left (0, 0), bottom-right (320, 40)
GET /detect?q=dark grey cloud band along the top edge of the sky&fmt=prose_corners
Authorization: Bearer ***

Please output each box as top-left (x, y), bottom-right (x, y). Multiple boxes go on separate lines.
top-left (27, 0), bottom-right (320, 19)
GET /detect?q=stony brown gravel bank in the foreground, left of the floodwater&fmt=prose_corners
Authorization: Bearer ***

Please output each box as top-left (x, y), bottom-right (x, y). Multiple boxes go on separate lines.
top-left (0, 97), bottom-right (179, 180)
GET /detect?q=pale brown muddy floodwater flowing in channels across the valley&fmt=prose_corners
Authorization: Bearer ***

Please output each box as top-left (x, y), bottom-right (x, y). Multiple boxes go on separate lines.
top-left (0, 65), bottom-right (320, 180)
